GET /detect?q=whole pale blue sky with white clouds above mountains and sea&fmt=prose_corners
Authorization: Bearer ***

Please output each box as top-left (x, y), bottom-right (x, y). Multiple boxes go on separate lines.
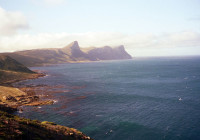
top-left (0, 0), bottom-right (200, 57)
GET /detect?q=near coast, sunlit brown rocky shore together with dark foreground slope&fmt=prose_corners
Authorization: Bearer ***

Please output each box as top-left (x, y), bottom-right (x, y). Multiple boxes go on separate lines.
top-left (0, 71), bottom-right (92, 140)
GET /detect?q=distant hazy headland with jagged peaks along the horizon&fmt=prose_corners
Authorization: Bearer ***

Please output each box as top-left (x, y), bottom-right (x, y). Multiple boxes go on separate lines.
top-left (3, 41), bottom-right (132, 66)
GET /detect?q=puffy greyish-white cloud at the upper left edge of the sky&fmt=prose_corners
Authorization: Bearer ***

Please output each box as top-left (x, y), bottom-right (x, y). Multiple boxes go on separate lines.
top-left (0, 7), bottom-right (29, 36)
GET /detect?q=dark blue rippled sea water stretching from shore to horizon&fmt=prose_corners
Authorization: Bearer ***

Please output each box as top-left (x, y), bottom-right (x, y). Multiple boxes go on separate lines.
top-left (15, 57), bottom-right (200, 140)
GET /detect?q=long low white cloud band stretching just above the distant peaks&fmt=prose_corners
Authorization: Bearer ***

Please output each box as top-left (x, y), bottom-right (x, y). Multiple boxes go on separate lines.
top-left (0, 31), bottom-right (200, 55)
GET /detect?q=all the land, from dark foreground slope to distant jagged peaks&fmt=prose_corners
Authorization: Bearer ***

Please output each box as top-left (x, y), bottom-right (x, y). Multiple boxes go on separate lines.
top-left (0, 41), bottom-right (132, 140)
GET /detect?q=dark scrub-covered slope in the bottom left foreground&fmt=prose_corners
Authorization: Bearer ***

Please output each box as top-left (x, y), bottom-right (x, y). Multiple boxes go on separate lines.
top-left (0, 111), bottom-right (90, 140)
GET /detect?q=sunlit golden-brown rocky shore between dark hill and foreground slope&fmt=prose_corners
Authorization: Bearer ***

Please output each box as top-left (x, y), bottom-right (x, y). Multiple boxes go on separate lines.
top-left (0, 73), bottom-right (54, 112)
